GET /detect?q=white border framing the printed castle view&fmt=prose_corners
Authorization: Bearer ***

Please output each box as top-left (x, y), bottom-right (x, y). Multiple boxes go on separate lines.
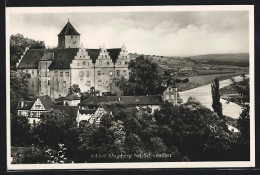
top-left (6, 5), bottom-right (255, 170)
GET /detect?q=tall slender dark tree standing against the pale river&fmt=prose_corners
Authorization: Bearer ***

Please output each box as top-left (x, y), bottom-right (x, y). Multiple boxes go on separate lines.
top-left (211, 78), bottom-right (223, 118)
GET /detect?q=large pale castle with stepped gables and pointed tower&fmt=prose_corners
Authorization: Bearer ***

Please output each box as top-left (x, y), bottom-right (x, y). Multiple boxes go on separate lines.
top-left (16, 21), bottom-right (130, 99)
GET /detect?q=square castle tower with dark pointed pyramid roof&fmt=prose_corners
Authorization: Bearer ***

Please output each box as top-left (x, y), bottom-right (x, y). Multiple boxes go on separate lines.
top-left (58, 21), bottom-right (80, 48)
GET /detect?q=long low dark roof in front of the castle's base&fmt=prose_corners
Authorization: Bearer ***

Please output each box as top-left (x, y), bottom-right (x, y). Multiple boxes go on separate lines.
top-left (79, 96), bottom-right (163, 106)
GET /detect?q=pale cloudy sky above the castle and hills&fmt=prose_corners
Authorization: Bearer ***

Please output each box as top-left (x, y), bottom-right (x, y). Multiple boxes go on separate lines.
top-left (8, 11), bottom-right (249, 56)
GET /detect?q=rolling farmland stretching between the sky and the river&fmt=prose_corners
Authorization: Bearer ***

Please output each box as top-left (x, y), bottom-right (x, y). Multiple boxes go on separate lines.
top-left (131, 53), bottom-right (249, 91)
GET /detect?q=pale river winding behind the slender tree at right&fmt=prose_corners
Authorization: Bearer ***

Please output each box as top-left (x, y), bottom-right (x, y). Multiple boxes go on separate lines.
top-left (179, 75), bottom-right (248, 119)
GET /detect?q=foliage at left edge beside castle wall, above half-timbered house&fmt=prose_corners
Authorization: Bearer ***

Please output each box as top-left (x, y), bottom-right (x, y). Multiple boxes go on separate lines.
top-left (10, 70), bottom-right (30, 114)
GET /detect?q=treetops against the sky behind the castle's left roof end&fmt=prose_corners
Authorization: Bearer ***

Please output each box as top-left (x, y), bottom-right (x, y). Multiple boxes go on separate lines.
top-left (10, 33), bottom-right (45, 67)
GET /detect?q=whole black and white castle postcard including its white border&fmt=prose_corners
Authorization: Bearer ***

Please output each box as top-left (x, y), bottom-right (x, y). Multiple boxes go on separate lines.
top-left (6, 5), bottom-right (255, 170)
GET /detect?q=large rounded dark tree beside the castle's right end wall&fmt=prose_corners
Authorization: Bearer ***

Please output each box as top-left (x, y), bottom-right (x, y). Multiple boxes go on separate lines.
top-left (116, 56), bottom-right (161, 95)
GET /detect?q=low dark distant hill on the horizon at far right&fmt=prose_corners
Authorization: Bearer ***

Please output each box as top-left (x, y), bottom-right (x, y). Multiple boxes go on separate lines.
top-left (190, 53), bottom-right (249, 67)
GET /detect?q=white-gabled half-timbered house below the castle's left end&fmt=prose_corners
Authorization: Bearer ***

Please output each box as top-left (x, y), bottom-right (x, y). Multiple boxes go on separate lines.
top-left (17, 95), bottom-right (54, 124)
